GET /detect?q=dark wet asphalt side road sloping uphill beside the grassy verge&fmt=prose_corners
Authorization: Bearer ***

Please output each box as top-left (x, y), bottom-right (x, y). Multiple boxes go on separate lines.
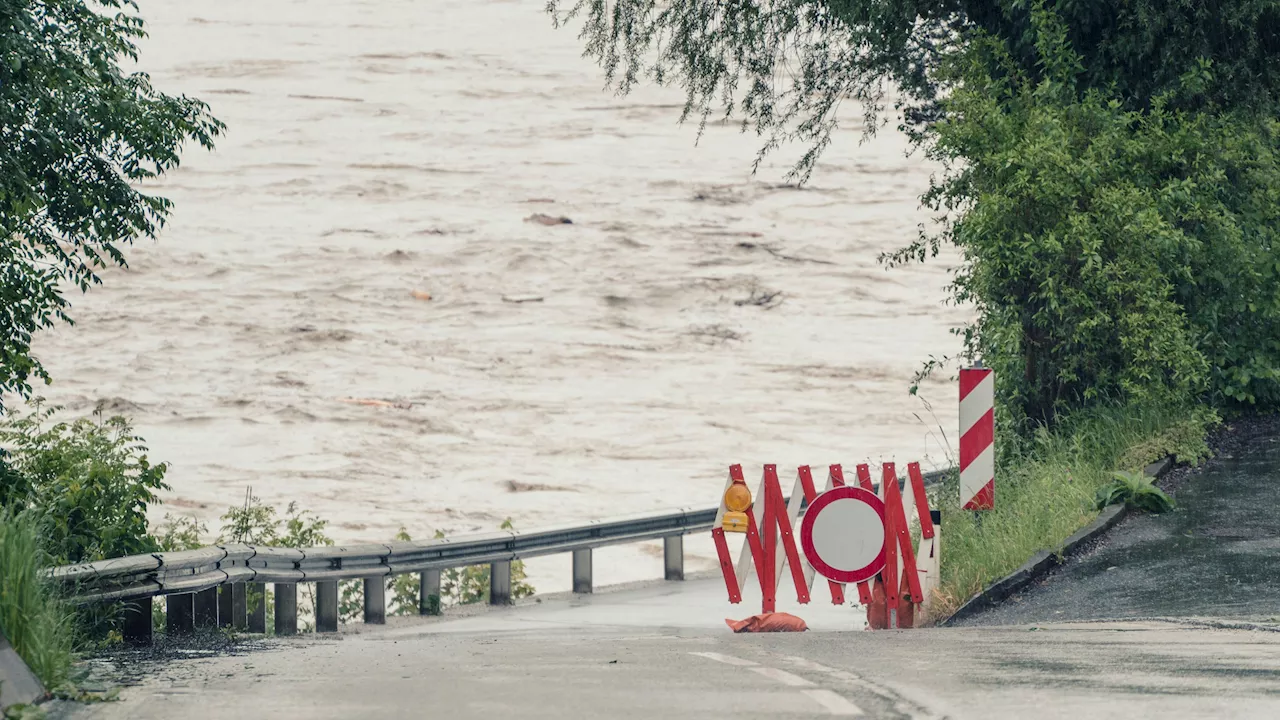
top-left (956, 418), bottom-right (1280, 627)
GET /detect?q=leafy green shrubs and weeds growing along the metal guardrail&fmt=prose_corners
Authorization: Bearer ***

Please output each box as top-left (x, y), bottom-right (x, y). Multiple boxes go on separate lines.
top-left (0, 400), bottom-right (534, 694)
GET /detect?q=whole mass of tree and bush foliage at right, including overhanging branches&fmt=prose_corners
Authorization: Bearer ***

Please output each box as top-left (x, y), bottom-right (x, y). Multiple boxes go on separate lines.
top-left (548, 0), bottom-right (1280, 424)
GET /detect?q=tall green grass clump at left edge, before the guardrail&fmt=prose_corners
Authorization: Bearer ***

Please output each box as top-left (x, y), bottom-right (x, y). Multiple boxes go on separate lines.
top-left (0, 510), bottom-right (76, 689)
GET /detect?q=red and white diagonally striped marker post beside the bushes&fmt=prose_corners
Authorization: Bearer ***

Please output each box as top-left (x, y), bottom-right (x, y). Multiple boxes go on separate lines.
top-left (960, 366), bottom-right (996, 510)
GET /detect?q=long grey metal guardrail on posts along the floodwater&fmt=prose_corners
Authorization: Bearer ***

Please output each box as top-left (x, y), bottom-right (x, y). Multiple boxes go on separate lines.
top-left (50, 470), bottom-right (954, 644)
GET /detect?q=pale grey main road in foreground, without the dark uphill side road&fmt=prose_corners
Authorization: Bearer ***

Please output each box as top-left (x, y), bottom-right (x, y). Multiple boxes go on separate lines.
top-left (55, 580), bottom-right (1280, 720)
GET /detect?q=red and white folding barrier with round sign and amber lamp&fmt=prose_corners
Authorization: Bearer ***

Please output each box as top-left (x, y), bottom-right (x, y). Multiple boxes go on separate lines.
top-left (712, 462), bottom-right (940, 629)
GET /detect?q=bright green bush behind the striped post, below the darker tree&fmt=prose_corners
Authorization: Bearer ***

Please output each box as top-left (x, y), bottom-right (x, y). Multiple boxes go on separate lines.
top-left (886, 5), bottom-right (1280, 428)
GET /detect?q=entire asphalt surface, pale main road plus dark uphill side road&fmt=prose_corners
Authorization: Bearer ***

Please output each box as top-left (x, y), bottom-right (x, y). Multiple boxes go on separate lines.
top-left (51, 419), bottom-right (1280, 720)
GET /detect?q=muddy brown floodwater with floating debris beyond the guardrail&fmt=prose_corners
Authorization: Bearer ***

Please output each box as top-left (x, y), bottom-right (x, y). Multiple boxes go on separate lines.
top-left (20, 0), bottom-right (968, 589)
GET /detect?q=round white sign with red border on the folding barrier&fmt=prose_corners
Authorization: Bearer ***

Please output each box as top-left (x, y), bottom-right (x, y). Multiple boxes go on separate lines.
top-left (800, 486), bottom-right (884, 583)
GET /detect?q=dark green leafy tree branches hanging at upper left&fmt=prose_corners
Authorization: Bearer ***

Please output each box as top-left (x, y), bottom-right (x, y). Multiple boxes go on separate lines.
top-left (0, 0), bottom-right (223, 404)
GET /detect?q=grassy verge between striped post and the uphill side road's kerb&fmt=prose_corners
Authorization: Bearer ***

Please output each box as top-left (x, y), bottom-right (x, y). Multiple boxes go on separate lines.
top-left (936, 397), bottom-right (1219, 616)
